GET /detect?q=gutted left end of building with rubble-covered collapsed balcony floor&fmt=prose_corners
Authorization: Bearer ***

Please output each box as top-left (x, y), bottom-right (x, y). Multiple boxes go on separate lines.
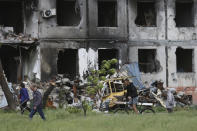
top-left (0, 0), bottom-right (39, 83)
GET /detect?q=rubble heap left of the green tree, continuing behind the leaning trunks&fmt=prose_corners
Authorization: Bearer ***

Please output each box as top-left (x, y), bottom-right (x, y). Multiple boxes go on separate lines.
top-left (0, 72), bottom-right (90, 109)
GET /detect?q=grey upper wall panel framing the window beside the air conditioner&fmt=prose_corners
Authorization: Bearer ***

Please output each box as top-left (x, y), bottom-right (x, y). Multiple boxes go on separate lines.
top-left (39, 0), bottom-right (87, 39)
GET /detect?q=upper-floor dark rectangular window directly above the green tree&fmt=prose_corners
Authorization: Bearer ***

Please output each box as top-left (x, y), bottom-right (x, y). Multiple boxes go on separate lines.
top-left (98, 1), bottom-right (117, 27)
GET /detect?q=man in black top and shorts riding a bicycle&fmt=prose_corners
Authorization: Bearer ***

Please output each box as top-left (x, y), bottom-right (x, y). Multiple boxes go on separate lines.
top-left (123, 79), bottom-right (138, 114)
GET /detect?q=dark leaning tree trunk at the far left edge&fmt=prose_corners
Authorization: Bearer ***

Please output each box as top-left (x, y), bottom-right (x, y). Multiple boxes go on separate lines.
top-left (0, 59), bottom-right (16, 110)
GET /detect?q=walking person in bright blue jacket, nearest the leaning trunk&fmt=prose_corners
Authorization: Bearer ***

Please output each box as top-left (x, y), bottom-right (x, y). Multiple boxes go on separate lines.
top-left (20, 83), bottom-right (31, 114)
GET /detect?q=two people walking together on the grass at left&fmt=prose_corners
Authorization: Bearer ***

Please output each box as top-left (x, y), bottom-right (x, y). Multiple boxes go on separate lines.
top-left (19, 82), bottom-right (46, 120)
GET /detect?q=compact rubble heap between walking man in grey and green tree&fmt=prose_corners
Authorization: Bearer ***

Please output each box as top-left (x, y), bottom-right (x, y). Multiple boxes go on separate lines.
top-left (38, 75), bottom-right (85, 108)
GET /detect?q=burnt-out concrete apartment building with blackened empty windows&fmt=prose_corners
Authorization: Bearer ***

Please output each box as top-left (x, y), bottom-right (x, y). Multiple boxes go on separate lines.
top-left (0, 0), bottom-right (197, 104)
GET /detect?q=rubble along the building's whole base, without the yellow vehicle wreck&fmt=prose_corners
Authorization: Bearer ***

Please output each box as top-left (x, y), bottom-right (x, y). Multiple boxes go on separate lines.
top-left (0, 67), bottom-right (192, 112)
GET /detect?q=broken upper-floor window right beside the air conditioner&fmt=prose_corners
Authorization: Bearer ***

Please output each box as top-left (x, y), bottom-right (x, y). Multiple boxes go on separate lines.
top-left (57, 0), bottom-right (81, 26)
